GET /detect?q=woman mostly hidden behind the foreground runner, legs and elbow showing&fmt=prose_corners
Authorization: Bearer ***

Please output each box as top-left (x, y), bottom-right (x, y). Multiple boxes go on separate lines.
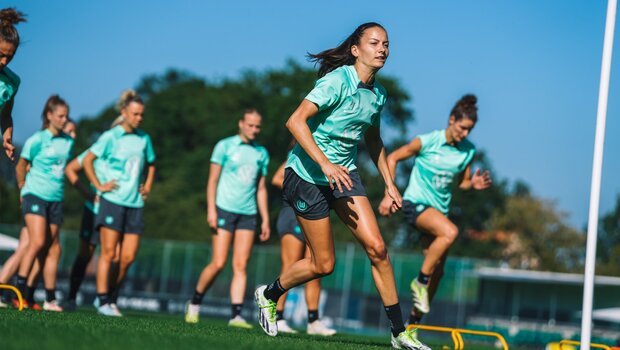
top-left (271, 157), bottom-right (336, 336)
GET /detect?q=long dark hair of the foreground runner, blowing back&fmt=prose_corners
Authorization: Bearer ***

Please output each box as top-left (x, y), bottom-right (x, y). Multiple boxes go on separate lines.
top-left (308, 22), bottom-right (385, 78)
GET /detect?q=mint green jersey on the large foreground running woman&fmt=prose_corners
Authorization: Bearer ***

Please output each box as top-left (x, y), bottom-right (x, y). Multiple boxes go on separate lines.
top-left (286, 66), bottom-right (387, 186)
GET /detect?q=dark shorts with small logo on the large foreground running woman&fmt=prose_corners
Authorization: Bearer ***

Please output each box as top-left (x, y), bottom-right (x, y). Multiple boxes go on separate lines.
top-left (283, 168), bottom-right (366, 220)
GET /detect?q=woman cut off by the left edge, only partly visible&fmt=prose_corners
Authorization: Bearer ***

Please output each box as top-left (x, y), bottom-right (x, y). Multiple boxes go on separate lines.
top-left (0, 8), bottom-right (26, 160)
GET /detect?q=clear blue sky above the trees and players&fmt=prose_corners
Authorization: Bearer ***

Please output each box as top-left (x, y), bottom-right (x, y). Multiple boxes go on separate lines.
top-left (2, 0), bottom-right (620, 227)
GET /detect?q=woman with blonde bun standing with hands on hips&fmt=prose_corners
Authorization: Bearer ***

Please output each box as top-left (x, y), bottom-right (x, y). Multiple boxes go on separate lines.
top-left (83, 90), bottom-right (155, 317)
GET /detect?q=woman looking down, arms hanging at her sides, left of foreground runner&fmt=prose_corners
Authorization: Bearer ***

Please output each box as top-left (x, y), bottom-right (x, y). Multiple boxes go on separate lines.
top-left (185, 108), bottom-right (270, 328)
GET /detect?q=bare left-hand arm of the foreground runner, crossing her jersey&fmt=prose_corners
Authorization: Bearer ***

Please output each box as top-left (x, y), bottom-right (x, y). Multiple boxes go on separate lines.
top-left (286, 100), bottom-right (353, 192)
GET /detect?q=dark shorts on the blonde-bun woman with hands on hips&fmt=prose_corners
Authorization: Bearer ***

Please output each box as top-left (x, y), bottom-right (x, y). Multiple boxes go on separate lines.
top-left (95, 197), bottom-right (144, 235)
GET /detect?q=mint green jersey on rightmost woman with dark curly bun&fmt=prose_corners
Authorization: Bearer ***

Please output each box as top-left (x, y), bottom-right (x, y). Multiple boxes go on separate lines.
top-left (403, 129), bottom-right (476, 215)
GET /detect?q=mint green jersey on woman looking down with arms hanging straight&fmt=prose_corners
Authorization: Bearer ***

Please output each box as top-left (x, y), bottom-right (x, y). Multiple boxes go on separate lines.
top-left (211, 135), bottom-right (269, 215)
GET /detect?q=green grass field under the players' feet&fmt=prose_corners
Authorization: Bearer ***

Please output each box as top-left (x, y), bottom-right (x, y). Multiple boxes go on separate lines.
top-left (0, 309), bottom-right (524, 350)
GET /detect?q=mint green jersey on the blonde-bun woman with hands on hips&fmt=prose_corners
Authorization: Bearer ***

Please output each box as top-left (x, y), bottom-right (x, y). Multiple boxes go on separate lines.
top-left (90, 125), bottom-right (155, 208)
